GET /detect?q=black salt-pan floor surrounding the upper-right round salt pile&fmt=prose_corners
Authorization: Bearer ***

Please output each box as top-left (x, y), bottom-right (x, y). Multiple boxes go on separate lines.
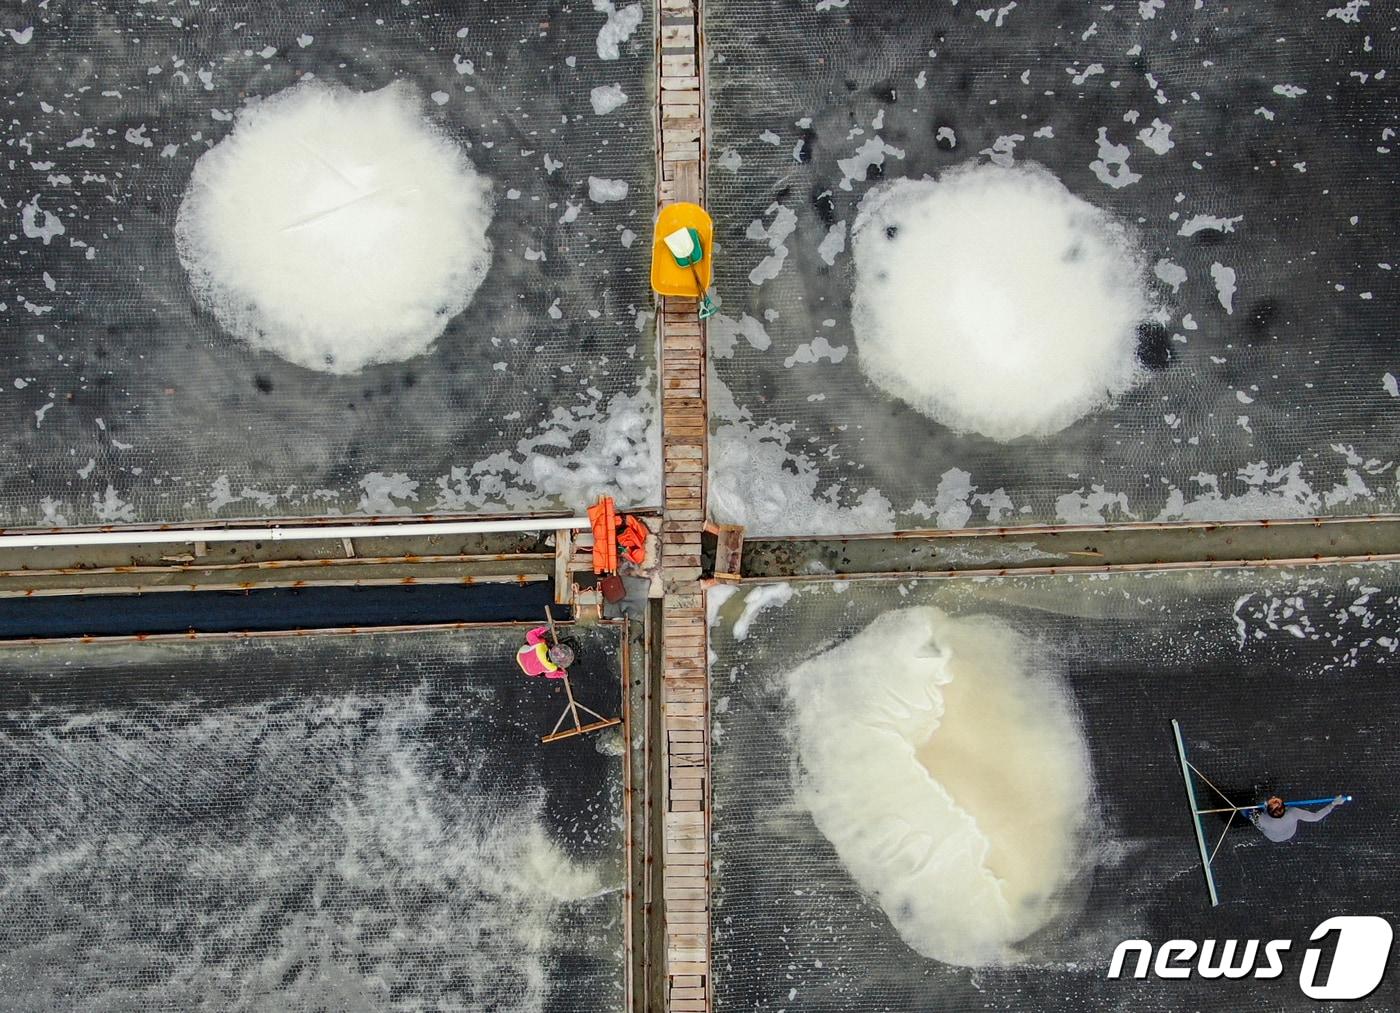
top-left (704, 0), bottom-right (1400, 534)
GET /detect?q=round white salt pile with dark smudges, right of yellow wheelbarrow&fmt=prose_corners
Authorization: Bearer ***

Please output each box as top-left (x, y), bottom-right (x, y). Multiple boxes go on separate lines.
top-left (851, 164), bottom-right (1152, 441)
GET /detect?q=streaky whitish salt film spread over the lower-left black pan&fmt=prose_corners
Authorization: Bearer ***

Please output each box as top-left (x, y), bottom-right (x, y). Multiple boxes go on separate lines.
top-left (0, 687), bottom-right (620, 1013)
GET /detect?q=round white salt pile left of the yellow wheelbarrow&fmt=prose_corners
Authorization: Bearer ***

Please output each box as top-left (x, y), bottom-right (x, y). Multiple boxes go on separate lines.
top-left (175, 81), bottom-right (491, 374)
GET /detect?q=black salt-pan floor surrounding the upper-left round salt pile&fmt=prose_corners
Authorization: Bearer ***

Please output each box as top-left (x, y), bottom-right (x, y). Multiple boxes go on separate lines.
top-left (0, 0), bottom-right (659, 527)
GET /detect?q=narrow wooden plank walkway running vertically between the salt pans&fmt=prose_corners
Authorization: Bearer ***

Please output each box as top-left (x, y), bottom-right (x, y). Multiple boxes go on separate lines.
top-left (657, 0), bottom-right (710, 1013)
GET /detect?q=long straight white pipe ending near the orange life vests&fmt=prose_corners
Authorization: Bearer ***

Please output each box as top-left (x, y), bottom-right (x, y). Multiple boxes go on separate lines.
top-left (0, 518), bottom-right (591, 548)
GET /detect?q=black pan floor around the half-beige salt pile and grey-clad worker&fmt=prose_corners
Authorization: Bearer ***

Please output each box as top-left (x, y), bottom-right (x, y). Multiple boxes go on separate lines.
top-left (711, 564), bottom-right (1400, 1013)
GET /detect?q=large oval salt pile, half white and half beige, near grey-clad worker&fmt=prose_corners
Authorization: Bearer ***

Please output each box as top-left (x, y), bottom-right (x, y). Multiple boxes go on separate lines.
top-left (789, 604), bottom-right (1093, 967)
